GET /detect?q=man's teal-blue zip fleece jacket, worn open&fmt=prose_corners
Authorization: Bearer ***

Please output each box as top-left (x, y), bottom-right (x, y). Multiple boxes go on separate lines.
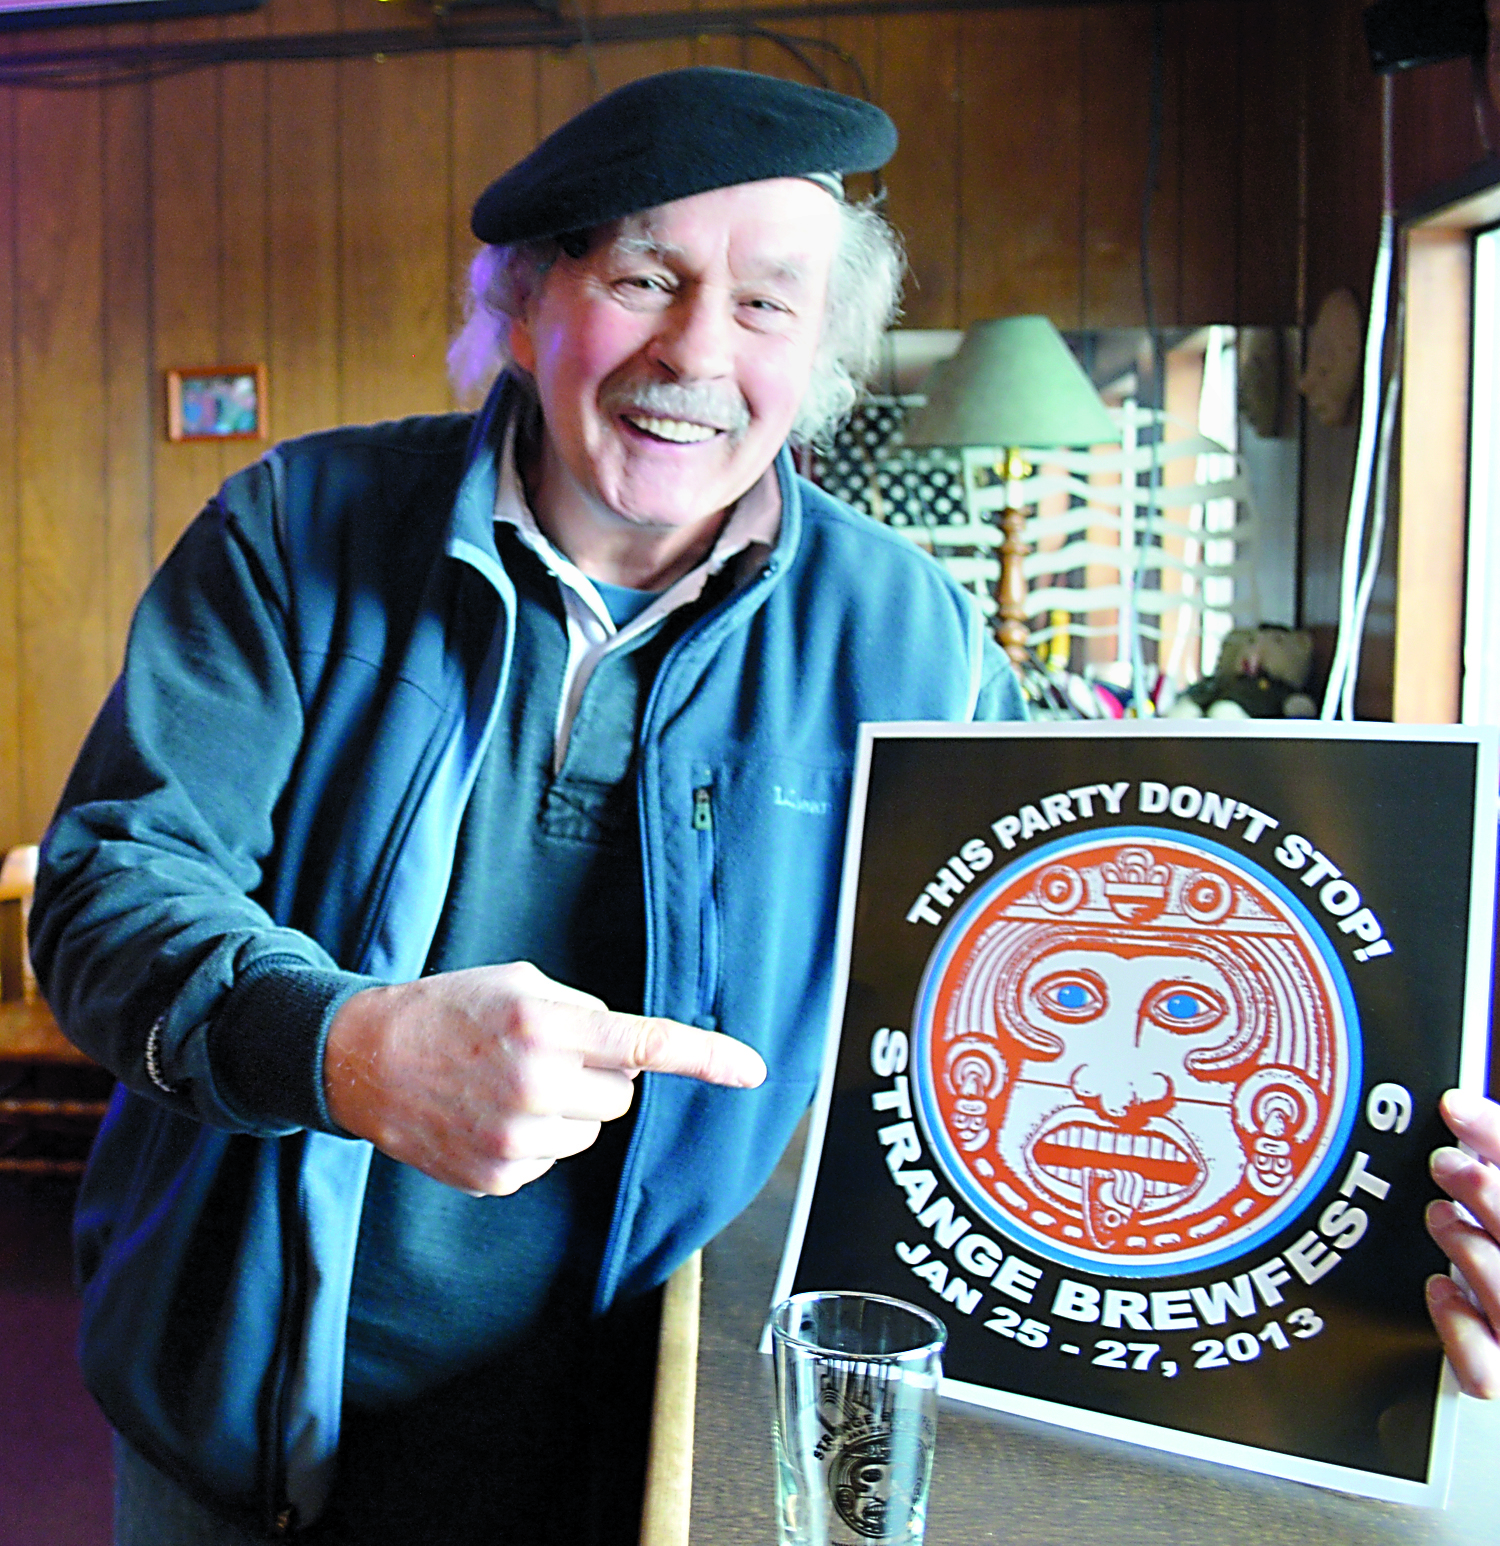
top-left (32, 382), bottom-right (1024, 1537)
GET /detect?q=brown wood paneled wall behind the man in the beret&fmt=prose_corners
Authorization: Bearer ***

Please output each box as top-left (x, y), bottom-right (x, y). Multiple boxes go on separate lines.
top-left (0, 0), bottom-right (1298, 847)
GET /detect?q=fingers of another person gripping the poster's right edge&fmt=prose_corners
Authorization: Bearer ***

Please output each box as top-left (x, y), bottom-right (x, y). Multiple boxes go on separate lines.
top-left (1427, 1090), bottom-right (1500, 1398)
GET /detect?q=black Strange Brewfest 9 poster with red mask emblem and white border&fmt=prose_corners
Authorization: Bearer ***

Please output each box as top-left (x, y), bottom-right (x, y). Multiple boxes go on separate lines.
top-left (776, 722), bottom-right (1497, 1504)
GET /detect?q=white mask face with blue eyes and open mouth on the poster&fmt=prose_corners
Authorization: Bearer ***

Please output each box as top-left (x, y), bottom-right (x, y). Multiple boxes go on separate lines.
top-left (996, 949), bottom-right (1245, 1246)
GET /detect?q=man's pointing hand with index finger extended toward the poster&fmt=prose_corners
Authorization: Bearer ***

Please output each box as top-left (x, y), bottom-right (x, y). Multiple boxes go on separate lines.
top-left (323, 962), bottom-right (765, 1197)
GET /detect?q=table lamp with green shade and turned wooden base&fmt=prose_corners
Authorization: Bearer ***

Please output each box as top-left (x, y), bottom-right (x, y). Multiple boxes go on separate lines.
top-left (903, 317), bottom-right (1120, 663)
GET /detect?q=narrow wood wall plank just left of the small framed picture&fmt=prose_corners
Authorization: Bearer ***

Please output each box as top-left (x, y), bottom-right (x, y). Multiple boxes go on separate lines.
top-left (102, 26), bottom-right (156, 676)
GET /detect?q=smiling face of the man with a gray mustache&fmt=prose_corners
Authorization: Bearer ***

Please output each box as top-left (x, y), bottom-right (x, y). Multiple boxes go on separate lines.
top-left (510, 178), bottom-right (840, 584)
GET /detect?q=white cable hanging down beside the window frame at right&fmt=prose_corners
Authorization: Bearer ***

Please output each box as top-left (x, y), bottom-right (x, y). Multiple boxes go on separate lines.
top-left (1322, 76), bottom-right (1398, 719)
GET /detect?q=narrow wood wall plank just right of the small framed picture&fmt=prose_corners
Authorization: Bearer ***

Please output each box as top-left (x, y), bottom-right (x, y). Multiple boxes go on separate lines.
top-left (266, 0), bottom-right (340, 439)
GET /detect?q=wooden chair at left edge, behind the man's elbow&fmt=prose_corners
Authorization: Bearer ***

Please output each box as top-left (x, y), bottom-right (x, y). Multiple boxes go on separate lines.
top-left (0, 844), bottom-right (110, 1175)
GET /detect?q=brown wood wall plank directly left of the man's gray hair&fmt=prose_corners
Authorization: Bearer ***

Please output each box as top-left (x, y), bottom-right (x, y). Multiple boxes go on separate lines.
top-left (339, 43), bottom-right (450, 422)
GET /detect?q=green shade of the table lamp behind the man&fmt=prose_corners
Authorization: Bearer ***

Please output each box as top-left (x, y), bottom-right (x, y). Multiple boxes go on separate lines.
top-left (903, 317), bottom-right (1120, 450)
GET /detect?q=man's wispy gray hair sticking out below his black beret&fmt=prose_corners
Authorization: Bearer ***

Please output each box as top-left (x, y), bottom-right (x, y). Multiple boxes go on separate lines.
top-left (448, 201), bottom-right (906, 445)
